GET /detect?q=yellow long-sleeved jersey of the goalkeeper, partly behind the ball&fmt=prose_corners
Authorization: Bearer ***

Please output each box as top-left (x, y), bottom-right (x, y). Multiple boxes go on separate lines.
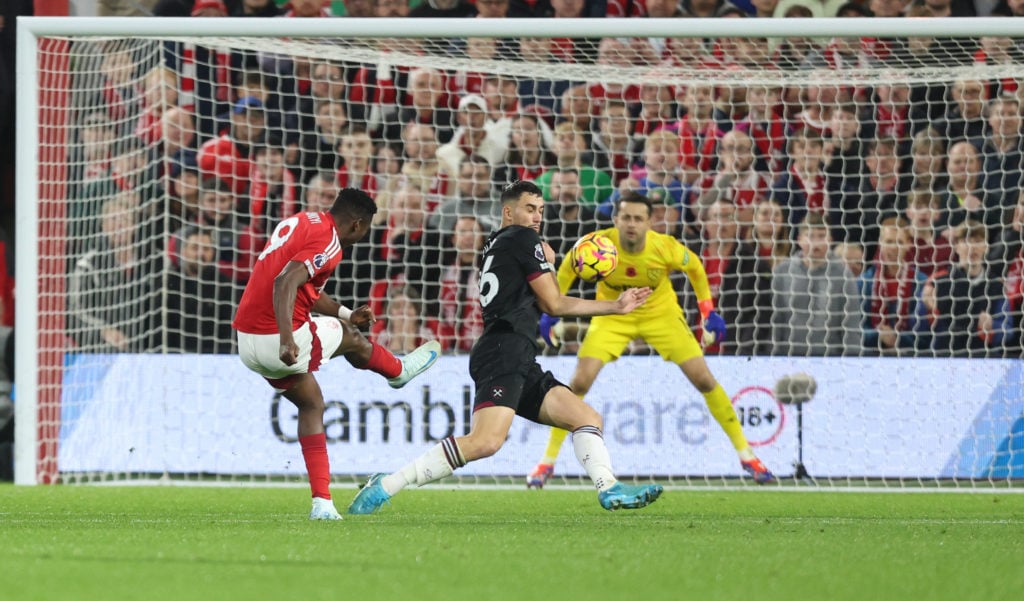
top-left (558, 227), bottom-right (711, 317)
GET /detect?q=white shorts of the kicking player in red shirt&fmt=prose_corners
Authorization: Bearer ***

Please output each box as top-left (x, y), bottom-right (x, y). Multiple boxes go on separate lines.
top-left (239, 315), bottom-right (344, 390)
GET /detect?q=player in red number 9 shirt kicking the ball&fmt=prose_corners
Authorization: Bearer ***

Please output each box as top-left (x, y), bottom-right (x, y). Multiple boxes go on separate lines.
top-left (233, 187), bottom-right (440, 520)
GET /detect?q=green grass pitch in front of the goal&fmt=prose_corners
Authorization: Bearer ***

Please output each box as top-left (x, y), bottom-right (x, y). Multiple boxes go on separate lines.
top-left (0, 485), bottom-right (1024, 601)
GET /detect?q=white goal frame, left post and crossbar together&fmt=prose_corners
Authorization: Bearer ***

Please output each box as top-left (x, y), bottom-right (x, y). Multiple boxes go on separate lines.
top-left (14, 17), bottom-right (1024, 485)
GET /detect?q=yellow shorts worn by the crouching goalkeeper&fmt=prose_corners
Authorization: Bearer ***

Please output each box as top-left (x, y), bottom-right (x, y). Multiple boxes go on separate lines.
top-left (577, 309), bottom-right (703, 364)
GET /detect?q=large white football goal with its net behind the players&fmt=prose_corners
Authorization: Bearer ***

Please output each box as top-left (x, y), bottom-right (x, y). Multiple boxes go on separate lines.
top-left (16, 18), bottom-right (1024, 487)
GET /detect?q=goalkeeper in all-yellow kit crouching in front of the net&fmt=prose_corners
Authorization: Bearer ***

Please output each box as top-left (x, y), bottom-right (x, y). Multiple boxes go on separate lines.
top-left (526, 192), bottom-right (774, 488)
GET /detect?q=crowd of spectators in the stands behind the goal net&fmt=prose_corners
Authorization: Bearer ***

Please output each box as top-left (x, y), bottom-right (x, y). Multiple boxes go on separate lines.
top-left (25, 0), bottom-right (1024, 357)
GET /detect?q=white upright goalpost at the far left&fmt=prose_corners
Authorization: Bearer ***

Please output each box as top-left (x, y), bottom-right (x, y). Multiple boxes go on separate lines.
top-left (14, 18), bottom-right (39, 484)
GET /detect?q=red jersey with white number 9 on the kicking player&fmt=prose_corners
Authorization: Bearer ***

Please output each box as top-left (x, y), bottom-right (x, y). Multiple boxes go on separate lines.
top-left (233, 213), bottom-right (342, 334)
